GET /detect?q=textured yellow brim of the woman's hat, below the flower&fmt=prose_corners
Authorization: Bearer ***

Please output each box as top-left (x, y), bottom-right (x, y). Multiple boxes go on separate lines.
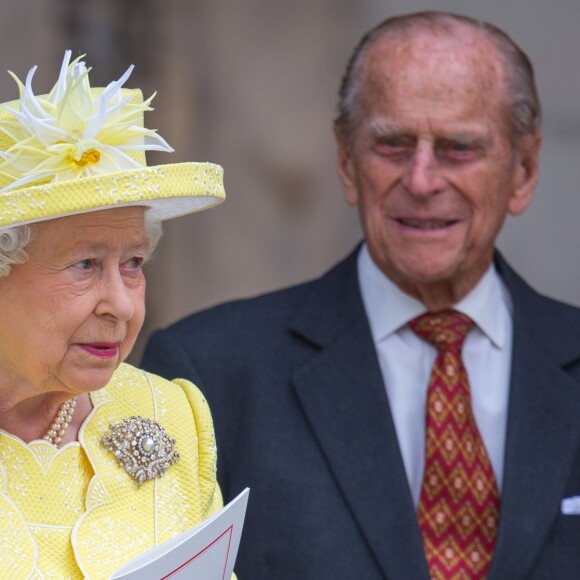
top-left (0, 163), bottom-right (225, 230)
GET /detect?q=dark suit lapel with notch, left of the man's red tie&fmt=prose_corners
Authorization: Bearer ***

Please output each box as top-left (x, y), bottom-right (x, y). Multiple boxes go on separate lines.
top-left (293, 255), bottom-right (428, 580)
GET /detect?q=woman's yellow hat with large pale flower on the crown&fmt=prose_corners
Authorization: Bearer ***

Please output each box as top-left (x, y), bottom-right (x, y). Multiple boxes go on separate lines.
top-left (0, 51), bottom-right (225, 230)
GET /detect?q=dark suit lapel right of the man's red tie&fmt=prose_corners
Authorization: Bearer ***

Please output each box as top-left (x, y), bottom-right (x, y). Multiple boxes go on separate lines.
top-left (489, 259), bottom-right (580, 580)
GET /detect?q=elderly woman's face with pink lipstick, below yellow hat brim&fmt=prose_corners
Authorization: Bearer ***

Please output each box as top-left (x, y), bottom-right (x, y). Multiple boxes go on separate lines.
top-left (0, 207), bottom-right (149, 394)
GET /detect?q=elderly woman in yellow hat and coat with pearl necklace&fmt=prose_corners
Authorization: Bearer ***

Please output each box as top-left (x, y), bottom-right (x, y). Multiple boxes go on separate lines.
top-left (0, 52), bottom-right (229, 579)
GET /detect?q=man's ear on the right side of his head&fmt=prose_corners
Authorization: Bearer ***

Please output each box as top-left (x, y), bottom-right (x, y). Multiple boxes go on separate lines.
top-left (508, 131), bottom-right (542, 215)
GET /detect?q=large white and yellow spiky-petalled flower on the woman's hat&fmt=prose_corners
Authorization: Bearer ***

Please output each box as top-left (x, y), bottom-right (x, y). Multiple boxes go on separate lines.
top-left (0, 50), bottom-right (173, 191)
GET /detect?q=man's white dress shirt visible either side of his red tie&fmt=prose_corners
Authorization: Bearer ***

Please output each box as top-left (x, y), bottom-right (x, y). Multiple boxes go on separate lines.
top-left (358, 245), bottom-right (513, 506)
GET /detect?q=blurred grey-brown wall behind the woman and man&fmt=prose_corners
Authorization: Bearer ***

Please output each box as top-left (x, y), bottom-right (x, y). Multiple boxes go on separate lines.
top-left (0, 0), bottom-right (580, 362)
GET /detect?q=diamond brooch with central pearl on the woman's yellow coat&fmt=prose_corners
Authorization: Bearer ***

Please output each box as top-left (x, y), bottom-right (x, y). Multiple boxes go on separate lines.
top-left (101, 417), bottom-right (179, 487)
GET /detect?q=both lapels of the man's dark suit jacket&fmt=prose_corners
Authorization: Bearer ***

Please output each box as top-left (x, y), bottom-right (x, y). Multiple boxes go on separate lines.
top-left (292, 254), bottom-right (580, 580)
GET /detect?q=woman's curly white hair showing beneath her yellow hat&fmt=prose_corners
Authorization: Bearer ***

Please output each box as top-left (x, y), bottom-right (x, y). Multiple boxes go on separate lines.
top-left (0, 212), bottom-right (163, 278)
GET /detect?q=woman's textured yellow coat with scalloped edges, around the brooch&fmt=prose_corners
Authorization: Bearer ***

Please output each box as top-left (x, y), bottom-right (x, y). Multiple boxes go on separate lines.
top-left (0, 365), bottom-right (222, 579)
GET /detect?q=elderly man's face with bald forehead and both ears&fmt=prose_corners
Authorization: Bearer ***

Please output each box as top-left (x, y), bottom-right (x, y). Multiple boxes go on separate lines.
top-left (339, 33), bottom-right (540, 301)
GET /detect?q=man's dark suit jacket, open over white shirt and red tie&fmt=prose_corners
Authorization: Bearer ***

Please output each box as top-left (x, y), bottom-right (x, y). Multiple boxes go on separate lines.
top-left (143, 252), bottom-right (580, 580)
